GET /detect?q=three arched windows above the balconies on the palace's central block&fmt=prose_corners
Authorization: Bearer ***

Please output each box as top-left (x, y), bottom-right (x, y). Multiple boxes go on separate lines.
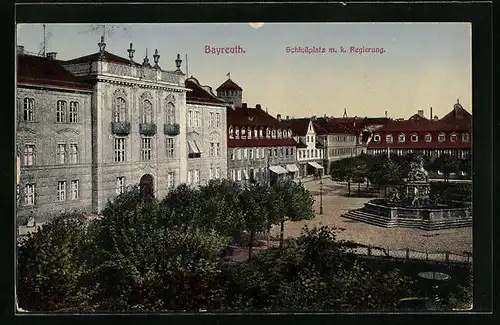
top-left (113, 97), bottom-right (175, 124)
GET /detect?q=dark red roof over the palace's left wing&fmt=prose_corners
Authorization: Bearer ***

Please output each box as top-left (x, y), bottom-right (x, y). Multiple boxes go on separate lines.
top-left (17, 55), bottom-right (91, 90)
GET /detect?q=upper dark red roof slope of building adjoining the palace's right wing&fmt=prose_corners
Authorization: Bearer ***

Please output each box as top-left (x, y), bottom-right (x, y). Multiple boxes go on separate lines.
top-left (227, 105), bottom-right (287, 129)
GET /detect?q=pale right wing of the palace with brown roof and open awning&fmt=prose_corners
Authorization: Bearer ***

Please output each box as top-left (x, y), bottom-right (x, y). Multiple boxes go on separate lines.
top-left (186, 77), bottom-right (227, 185)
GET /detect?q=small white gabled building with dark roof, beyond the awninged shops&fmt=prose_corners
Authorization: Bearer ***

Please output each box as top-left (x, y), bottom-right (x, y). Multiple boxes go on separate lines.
top-left (283, 117), bottom-right (324, 178)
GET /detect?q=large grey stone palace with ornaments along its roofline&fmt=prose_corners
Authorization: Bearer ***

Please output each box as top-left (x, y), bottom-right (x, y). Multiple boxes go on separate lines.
top-left (17, 39), bottom-right (199, 220)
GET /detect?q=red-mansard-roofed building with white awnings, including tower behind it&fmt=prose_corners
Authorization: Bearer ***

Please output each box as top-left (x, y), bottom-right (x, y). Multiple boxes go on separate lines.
top-left (217, 79), bottom-right (299, 183)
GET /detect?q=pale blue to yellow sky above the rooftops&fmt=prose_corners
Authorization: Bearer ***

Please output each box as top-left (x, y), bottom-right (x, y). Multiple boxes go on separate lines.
top-left (17, 23), bottom-right (472, 118)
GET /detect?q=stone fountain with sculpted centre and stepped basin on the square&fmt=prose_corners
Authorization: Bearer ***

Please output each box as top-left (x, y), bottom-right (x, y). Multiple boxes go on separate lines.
top-left (344, 157), bottom-right (472, 230)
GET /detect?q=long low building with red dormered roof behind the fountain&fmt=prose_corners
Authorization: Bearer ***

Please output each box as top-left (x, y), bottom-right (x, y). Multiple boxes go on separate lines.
top-left (367, 100), bottom-right (472, 158)
